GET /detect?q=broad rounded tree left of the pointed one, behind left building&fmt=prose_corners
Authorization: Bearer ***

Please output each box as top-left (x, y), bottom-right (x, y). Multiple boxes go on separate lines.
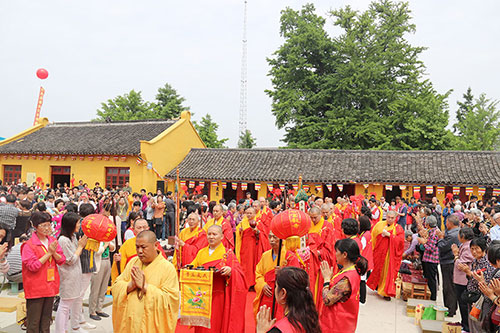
top-left (95, 90), bottom-right (157, 121)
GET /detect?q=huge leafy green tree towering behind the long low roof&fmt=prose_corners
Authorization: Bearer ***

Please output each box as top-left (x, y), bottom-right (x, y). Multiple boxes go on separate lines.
top-left (266, 0), bottom-right (453, 149)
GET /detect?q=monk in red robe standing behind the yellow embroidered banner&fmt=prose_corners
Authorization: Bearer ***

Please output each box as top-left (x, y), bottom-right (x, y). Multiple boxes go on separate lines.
top-left (191, 225), bottom-right (248, 333)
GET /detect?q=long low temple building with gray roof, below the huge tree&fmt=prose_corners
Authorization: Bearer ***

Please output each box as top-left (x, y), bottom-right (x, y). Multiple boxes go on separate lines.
top-left (166, 148), bottom-right (500, 202)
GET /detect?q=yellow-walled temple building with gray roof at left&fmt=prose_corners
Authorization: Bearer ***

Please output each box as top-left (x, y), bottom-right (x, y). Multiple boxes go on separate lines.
top-left (0, 111), bottom-right (205, 192)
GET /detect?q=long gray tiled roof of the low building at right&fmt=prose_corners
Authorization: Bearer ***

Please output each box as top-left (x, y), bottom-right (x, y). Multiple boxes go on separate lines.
top-left (167, 149), bottom-right (500, 186)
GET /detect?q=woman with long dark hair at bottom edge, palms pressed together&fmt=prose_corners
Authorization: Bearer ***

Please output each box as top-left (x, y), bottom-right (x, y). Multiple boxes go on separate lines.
top-left (257, 267), bottom-right (321, 333)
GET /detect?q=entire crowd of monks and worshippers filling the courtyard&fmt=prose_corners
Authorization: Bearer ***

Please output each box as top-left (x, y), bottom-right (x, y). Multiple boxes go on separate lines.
top-left (0, 181), bottom-right (500, 332)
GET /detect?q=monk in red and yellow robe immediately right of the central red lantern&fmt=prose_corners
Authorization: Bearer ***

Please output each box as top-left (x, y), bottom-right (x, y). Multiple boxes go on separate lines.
top-left (306, 207), bottom-right (337, 310)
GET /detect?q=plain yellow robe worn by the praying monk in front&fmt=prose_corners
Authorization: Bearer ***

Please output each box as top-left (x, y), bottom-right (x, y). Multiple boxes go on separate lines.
top-left (111, 255), bottom-right (179, 333)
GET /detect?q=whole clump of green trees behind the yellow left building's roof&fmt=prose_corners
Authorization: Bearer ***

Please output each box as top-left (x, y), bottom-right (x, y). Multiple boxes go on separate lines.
top-left (95, 83), bottom-right (187, 121)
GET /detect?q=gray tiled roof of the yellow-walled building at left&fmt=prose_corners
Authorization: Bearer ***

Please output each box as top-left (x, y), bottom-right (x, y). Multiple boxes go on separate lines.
top-left (0, 119), bottom-right (176, 155)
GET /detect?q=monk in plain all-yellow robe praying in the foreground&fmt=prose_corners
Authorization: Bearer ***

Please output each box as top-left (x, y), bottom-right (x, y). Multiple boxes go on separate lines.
top-left (111, 231), bottom-right (179, 333)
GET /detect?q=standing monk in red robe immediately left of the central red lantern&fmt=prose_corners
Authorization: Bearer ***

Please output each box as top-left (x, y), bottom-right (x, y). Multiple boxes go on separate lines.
top-left (236, 206), bottom-right (270, 287)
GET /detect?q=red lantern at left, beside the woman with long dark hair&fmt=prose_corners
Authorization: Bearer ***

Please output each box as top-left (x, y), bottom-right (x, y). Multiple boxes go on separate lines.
top-left (82, 214), bottom-right (116, 251)
